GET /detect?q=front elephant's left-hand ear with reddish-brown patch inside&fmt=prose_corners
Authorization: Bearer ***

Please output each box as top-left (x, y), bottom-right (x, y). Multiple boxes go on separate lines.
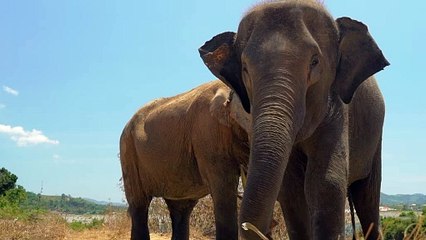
top-left (198, 32), bottom-right (250, 113)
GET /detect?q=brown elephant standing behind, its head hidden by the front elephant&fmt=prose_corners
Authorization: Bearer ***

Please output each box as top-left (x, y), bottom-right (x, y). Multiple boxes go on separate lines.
top-left (120, 80), bottom-right (251, 239)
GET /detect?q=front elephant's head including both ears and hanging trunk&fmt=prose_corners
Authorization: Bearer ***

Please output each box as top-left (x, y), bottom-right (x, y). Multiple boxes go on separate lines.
top-left (199, 1), bottom-right (389, 238)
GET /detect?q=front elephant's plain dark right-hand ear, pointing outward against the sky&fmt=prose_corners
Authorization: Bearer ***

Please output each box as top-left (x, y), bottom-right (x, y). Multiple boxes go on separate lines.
top-left (336, 17), bottom-right (389, 103)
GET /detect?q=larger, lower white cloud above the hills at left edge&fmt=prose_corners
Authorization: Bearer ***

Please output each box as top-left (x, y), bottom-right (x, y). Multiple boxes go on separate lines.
top-left (0, 124), bottom-right (59, 147)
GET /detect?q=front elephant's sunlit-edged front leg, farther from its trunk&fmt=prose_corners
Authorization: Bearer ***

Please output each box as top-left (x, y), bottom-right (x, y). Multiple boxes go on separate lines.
top-left (305, 134), bottom-right (349, 239)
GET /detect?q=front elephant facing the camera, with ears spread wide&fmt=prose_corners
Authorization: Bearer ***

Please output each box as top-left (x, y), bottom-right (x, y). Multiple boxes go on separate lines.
top-left (199, 1), bottom-right (389, 239)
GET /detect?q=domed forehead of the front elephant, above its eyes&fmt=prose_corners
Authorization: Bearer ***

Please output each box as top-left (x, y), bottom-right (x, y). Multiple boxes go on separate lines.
top-left (237, 2), bottom-right (334, 62)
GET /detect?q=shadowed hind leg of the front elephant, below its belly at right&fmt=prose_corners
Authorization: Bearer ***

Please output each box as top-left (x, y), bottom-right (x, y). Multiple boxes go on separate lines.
top-left (349, 144), bottom-right (381, 240)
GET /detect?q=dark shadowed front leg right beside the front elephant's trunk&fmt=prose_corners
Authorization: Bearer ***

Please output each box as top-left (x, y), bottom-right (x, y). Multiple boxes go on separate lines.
top-left (278, 151), bottom-right (311, 240)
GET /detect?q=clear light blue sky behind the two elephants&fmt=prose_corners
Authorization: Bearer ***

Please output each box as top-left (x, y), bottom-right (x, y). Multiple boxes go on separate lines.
top-left (0, 0), bottom-right (426, 202)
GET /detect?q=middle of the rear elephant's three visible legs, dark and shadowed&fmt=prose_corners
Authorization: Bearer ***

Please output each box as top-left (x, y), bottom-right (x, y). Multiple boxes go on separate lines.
top-left (165, 199), bottom-right (198, 240)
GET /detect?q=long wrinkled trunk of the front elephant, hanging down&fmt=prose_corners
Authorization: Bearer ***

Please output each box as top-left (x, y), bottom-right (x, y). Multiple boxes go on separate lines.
top-left (240, 78), bottom-right (304, 239)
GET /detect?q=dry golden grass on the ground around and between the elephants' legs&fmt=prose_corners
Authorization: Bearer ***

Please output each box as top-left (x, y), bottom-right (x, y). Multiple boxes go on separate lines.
top-left (0, 197), bottom-right (426, 240)
